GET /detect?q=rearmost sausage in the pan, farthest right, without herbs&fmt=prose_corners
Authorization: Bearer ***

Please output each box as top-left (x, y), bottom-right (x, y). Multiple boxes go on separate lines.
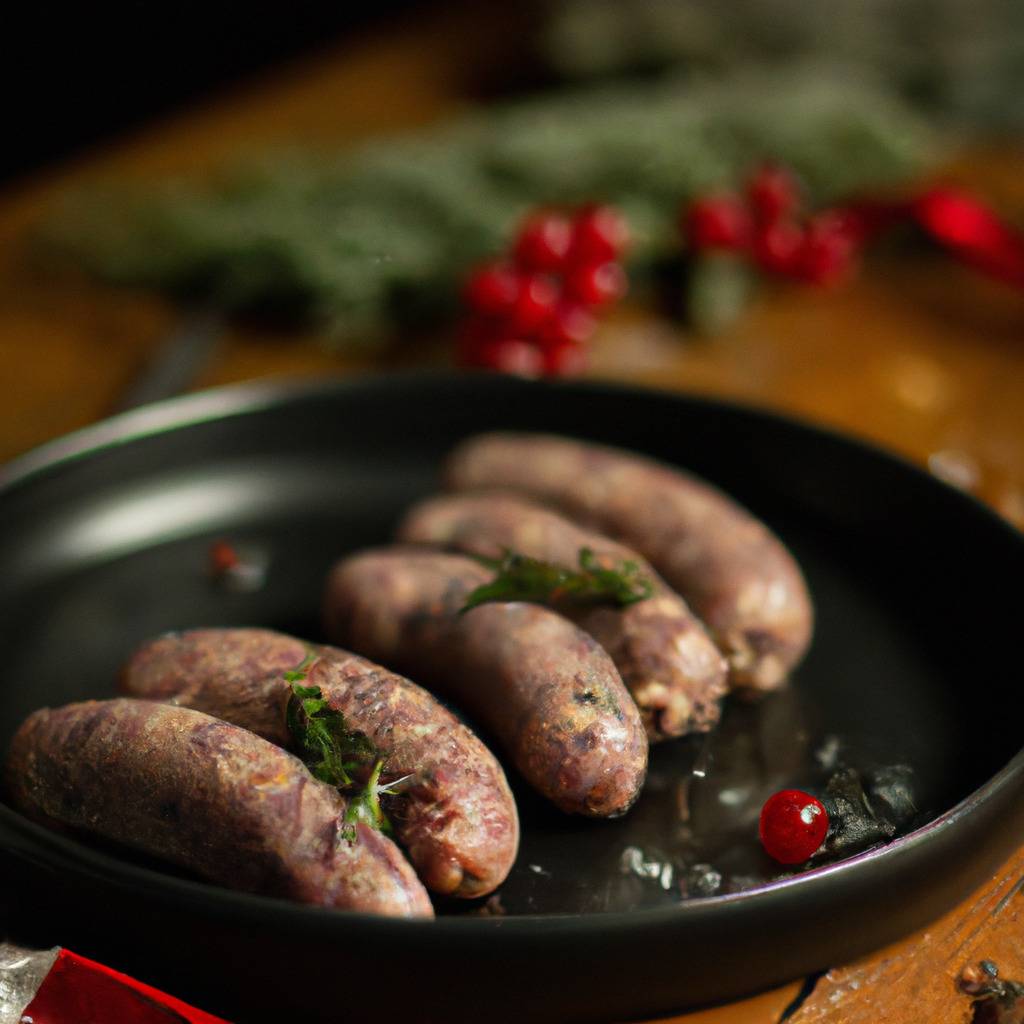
top-left (445, 433), bottom-right (814, 690)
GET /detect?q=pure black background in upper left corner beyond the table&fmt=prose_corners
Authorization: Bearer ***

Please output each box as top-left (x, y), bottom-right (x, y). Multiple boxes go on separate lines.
top-left (0, 0), bottom-right (428, 181)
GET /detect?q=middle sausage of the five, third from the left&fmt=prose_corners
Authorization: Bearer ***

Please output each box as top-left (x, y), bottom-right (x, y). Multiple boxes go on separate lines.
top-left (325, 549), bottom-right (647, 817)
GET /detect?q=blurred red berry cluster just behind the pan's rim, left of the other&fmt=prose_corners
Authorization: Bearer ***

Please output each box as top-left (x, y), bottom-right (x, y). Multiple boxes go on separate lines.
top-left (459, 206), bottom-right (629, 376)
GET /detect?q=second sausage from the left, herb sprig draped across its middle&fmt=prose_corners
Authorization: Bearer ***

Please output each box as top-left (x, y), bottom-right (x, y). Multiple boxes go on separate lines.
top-left (121, 629), bottom-right (519, 897)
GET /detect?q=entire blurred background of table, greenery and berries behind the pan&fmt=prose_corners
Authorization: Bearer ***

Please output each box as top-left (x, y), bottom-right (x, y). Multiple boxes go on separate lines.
top-left (0, 0), bottom-right (1024, 522)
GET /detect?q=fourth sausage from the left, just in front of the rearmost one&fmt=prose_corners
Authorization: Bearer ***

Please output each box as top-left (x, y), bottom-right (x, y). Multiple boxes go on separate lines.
top-left (397, 494), bottom-right (726, 742)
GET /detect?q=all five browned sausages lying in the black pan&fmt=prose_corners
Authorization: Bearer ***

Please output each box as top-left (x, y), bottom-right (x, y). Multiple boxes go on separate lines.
top-left (6, 433), bottom-right (813, 916)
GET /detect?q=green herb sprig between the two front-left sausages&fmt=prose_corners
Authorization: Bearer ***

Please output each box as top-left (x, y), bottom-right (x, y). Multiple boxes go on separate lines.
top-left (285, 651), bottom-right (410, 842)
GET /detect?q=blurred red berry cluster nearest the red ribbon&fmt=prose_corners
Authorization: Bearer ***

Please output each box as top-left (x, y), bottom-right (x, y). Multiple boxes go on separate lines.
top-left (680, 164), bottom-right (864, 285)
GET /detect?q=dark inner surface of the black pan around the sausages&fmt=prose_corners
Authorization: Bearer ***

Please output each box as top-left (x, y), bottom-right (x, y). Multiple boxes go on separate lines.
top-left (0, 378), bottom-right (1021, 914)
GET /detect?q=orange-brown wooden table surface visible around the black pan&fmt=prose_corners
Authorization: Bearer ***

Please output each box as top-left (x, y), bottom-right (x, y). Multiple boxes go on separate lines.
top-left (0, 4), bottom-right (1024, 1024)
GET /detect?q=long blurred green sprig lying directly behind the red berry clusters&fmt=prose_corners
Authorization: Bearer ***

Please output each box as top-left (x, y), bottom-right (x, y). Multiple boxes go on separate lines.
top-left (45, 69), bottom-right (932, 346)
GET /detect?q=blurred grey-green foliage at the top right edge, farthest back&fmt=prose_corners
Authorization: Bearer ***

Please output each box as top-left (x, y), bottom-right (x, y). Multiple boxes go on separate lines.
top-left (539, 0), bottom-right (1024, 134)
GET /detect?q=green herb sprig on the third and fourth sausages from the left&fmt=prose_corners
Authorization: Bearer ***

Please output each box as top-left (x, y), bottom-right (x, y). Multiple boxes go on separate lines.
top-left (461, 548), bottom-right (654, 611)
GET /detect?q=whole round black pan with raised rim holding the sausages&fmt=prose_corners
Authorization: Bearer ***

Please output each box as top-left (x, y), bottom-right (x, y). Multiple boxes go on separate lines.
top-left (0, 374), bottom-right (1024, 1022)
